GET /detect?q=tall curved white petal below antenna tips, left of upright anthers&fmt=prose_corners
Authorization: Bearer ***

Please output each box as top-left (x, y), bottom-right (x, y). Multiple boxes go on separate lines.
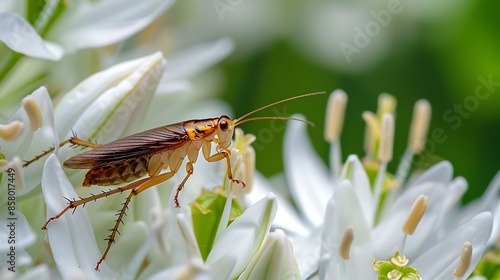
top-left (283, 115), bottom-right (334, 226)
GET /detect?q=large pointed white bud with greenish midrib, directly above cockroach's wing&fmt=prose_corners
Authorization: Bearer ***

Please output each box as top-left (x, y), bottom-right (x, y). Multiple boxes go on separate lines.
top-left (55, 52), bottom-right (165, 147)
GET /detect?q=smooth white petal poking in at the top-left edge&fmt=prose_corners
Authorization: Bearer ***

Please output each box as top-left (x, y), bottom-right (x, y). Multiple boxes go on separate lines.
top-left (0, 13), bottom-right (64, 60)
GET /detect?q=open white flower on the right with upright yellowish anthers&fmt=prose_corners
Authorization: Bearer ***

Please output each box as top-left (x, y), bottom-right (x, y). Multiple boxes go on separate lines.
top-left (248, 91), bottom-right (500, 279)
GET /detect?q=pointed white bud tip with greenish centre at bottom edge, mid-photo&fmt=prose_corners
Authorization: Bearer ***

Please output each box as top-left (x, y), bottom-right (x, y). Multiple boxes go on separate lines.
top-left (239, 230), bottom-right (300, 279)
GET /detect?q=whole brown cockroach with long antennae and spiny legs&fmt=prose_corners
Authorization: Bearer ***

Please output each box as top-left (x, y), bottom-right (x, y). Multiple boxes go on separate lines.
top-left (36, 92), bottom-right (325, 271)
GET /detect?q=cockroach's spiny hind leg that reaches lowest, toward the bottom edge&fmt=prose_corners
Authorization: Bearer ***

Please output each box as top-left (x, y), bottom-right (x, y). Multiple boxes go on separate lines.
top-left (94, 171), bottom-right (177, 271)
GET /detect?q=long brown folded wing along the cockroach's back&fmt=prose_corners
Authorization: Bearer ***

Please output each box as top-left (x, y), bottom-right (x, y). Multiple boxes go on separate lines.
top-left (64, 123), bottom-right (189, 169)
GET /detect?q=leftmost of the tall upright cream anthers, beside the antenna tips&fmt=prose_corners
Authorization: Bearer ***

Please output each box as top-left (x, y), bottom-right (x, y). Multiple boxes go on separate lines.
top-left (325, 89), bottom-right (347, 143)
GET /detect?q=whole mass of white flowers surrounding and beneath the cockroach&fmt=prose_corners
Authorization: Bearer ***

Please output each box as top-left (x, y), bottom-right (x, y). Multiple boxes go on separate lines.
top-left (0, 0), bottom-right (500, 279)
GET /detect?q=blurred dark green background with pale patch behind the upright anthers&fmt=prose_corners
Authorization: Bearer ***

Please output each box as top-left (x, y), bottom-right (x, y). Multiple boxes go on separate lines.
top-left (170, 0), bottom-right (500, 201)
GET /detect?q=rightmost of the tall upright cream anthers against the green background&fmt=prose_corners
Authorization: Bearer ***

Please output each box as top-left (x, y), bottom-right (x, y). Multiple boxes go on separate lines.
top-left (408, 99), bottom-right (431, 154)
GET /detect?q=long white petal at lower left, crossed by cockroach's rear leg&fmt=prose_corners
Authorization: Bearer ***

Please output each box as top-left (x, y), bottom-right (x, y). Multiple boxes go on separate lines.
top-left (42, 155), bottom-right (115, 279)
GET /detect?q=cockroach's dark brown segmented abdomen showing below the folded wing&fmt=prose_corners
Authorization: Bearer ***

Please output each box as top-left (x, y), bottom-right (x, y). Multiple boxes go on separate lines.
top-left (82, 157), bottom-right (149, 187)
